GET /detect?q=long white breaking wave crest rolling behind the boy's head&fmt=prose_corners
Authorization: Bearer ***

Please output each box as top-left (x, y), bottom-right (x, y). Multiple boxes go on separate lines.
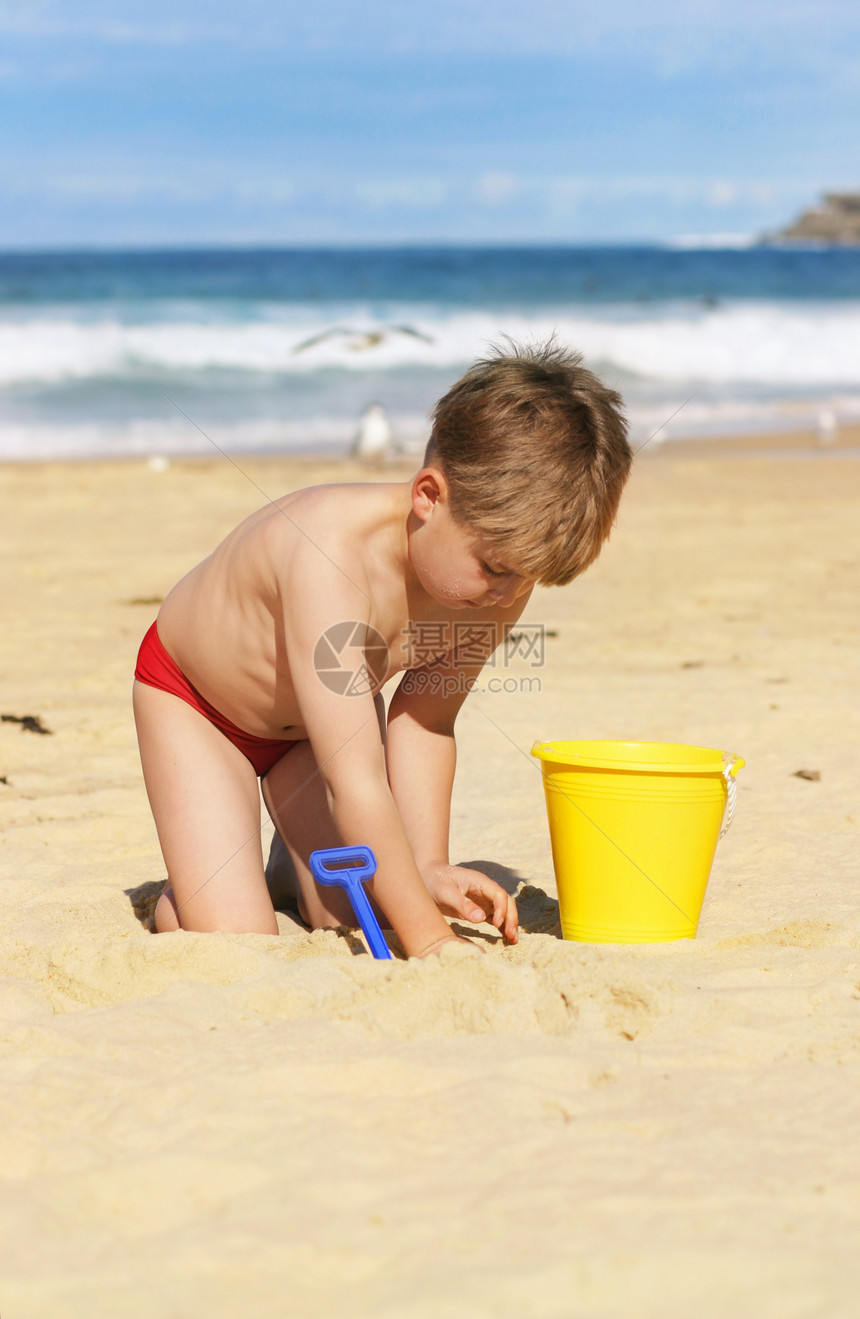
top-left (0, 302), bottom-right (860, 390)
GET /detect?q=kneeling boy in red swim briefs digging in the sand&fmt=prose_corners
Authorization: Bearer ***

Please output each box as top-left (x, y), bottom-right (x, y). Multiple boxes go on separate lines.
top-left (135, 340), bottom-right (630, 956)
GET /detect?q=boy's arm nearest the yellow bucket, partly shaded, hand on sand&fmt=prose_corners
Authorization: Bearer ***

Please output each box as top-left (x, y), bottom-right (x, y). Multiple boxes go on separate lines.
top-left (388, 596), bottom-right (528, 942)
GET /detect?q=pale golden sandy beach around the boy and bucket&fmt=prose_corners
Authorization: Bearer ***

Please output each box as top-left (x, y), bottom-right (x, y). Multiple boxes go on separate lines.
top-left (0, 430), bottom-right (860, 1319)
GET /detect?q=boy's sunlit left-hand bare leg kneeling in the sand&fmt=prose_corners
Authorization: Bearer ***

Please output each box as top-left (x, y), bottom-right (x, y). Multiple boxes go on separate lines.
top-left (133, 682), bottom-right (278, 934)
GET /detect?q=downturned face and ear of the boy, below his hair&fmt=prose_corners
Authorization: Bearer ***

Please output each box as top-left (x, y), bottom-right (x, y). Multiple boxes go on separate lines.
top-left (409, 468), bottom-right (534, 609)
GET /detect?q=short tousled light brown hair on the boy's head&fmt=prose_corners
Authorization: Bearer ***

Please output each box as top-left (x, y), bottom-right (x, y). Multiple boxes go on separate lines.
top-left (425, 338), bottom-right (633, 586)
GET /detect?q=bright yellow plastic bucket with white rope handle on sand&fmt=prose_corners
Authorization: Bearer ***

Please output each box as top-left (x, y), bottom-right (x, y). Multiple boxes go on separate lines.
top-left (532, 741), bottom-right (745, 943)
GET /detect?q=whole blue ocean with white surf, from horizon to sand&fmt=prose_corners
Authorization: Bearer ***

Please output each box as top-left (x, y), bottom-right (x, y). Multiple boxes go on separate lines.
top-left (0, 245), bottom-right (860, 460)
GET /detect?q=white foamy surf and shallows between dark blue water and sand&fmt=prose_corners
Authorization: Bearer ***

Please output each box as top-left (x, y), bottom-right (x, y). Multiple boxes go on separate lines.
top-left (0, 301), bottom-right (860, 458)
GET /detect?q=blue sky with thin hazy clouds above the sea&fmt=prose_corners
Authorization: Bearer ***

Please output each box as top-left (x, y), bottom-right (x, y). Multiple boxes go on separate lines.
top-left (0, 0), bottom-right (860, 248)
